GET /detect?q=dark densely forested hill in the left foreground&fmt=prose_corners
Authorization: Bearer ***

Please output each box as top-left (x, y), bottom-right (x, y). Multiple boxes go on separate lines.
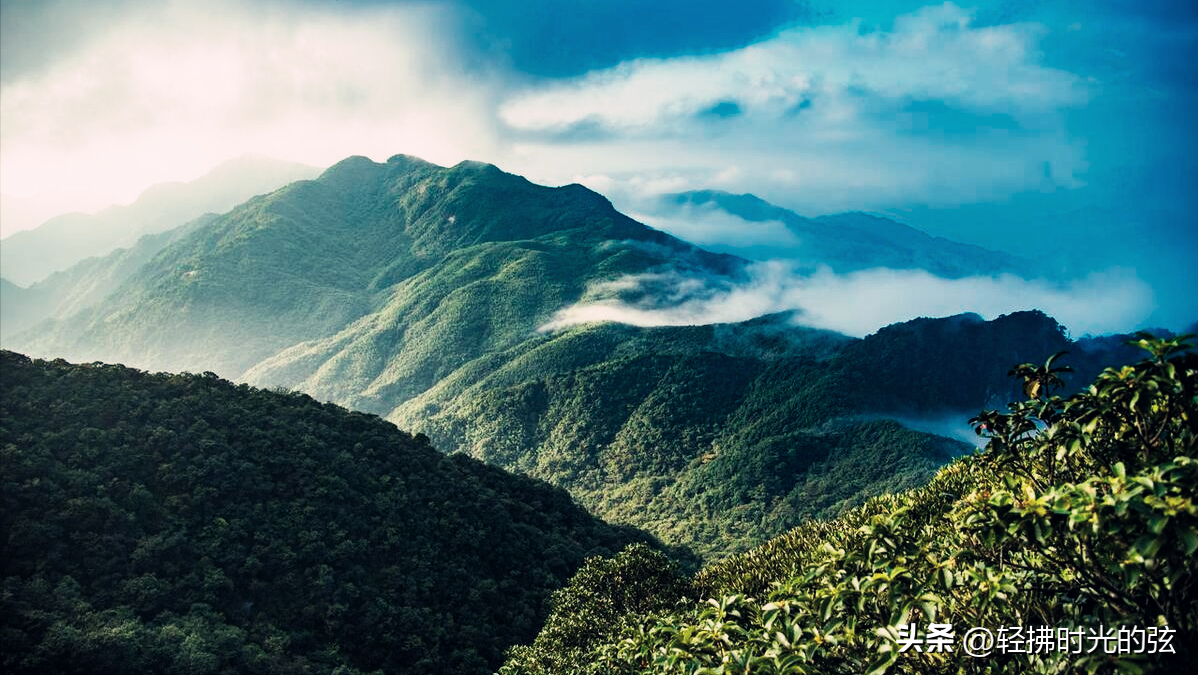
top-left (0, 351), bottom-right (648, 675)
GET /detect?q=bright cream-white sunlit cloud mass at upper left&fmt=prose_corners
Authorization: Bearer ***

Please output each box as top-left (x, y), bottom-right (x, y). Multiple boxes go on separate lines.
top-left (0, 0), bottom-right (495, 206)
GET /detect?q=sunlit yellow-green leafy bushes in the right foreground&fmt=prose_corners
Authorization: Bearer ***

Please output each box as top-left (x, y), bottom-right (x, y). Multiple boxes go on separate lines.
top-left (500, 335), bottom-right (1198, 675)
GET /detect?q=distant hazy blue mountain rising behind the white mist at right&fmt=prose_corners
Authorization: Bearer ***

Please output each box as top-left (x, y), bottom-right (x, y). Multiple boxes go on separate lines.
top-left (662, 191), bottom-right (1046, 278)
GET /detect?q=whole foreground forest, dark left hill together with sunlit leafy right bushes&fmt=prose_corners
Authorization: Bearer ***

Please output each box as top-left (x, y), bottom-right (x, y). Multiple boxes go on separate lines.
top-left (0, 333), bottom-right (1198, 675)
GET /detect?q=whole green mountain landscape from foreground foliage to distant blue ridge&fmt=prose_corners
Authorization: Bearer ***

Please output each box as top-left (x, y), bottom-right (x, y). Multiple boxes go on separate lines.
top-left (0, 150), bottom-right (1198, 675)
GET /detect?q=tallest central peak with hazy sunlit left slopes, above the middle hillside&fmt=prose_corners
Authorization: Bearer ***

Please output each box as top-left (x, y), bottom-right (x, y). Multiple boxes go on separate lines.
top-left (13, 156), bottom-right (739, 381)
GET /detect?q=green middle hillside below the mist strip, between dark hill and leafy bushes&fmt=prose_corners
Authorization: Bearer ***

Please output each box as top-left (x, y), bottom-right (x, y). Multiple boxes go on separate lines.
top-left (391, 313), bottom-right (1096, 560)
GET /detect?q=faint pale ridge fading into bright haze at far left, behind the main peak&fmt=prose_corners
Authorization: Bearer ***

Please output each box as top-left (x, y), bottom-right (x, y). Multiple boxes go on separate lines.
top-left (0, 155), bottom-right (320, 287)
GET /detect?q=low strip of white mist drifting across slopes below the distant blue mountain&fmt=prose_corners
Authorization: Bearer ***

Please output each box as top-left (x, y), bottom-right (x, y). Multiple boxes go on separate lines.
top-left (541, 261), bottom-right (1155, 337)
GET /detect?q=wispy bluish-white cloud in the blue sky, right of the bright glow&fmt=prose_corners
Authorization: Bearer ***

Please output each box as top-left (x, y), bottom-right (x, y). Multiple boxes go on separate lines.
top-left (498, 4), bottom-right (1091, 213)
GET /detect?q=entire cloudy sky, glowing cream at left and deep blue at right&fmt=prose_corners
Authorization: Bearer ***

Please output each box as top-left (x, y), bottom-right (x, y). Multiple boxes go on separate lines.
top-left (0, 0), bottom-right (1198, 332)
